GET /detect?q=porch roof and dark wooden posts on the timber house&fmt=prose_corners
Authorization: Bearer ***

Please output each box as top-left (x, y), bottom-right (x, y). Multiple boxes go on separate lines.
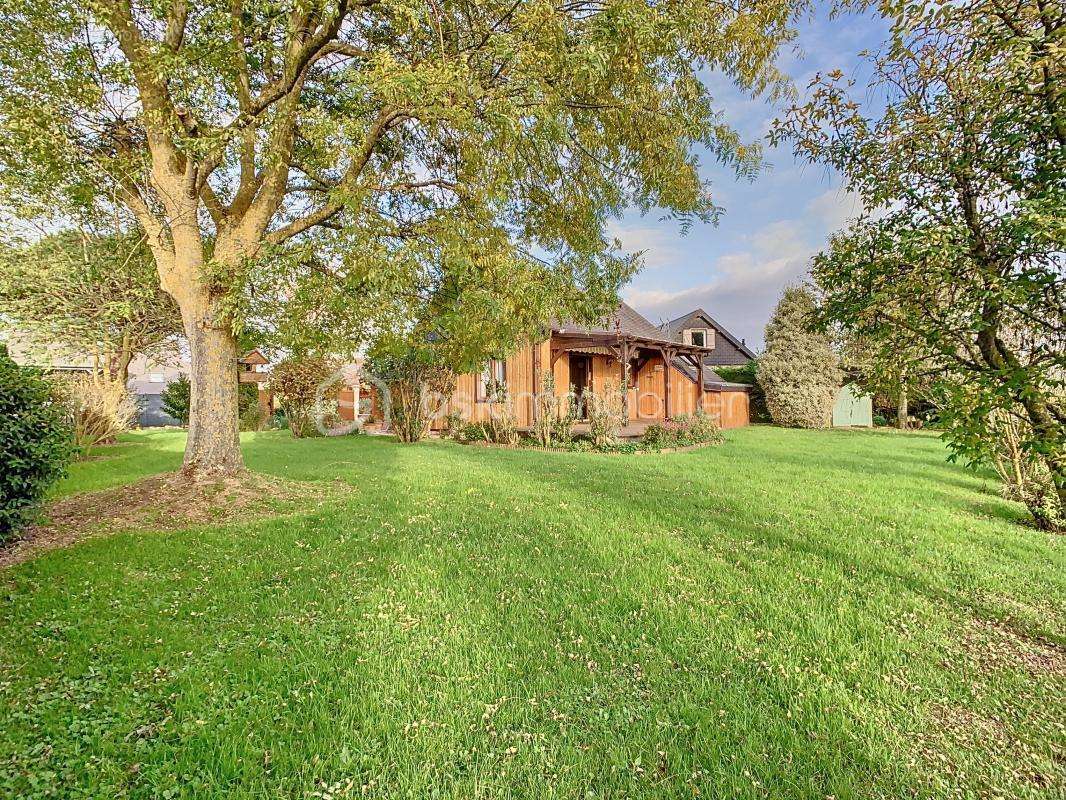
top-left (534, 303), bottom-right (709, 419)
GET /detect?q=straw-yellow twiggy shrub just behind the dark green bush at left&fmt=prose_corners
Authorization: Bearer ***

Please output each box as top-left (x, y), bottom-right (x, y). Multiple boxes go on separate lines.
top-left (55, 375), bottom-right (138, 455)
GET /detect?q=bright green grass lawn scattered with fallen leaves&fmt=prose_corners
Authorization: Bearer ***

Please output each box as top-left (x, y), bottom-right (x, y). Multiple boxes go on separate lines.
top-left (0, 427), bottom-right (1066, 800)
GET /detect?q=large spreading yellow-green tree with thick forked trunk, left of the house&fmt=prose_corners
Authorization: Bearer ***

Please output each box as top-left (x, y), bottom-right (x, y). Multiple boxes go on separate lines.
top-left (0, 0), bottom-right (798, 470)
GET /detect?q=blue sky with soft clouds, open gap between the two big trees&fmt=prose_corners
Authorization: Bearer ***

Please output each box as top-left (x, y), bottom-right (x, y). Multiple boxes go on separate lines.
top-left (610, 4), bottom-right (887, 351)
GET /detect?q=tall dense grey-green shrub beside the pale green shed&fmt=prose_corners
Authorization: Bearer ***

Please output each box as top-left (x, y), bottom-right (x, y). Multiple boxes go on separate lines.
top-left (757, 288), bottom-right (843, 428)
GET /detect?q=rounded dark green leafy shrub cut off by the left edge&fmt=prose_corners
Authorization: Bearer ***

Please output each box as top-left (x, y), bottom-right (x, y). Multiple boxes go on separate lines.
top-left (0, 347), bottom-right (71, 544)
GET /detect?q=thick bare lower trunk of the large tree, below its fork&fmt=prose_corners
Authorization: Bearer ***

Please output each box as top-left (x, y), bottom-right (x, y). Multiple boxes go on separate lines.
top-left (181, 295), bottom-right (244, 478)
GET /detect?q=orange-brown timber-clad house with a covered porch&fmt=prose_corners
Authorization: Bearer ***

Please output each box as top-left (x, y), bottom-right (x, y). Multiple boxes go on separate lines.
top-left (435, 303), bottom-right (749, 428)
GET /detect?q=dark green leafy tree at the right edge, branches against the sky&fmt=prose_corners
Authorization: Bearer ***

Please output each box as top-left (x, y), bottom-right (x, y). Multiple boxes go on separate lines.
top-left (776, 0), bottom-right (1066, 529)
